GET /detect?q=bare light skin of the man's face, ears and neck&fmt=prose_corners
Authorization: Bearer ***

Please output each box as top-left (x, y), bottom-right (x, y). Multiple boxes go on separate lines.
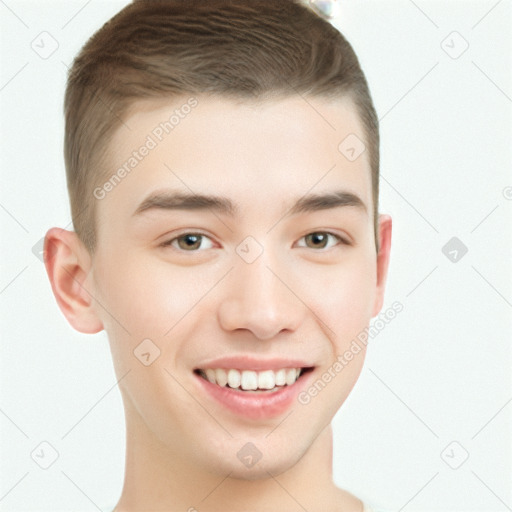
top-left (46, 96), bottom-right (392, 512)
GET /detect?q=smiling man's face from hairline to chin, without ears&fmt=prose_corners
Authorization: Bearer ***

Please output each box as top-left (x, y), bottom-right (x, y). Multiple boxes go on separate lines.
top-left (72, 96), bottom-right (388, 479)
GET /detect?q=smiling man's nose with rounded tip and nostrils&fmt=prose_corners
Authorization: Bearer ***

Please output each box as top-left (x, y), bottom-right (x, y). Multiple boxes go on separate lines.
top-left (218, 252), bottom-right (307, 340)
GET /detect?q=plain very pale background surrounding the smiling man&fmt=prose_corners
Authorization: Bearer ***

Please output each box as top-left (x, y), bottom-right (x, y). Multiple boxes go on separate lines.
top-left (0, 0), bottom-right (512, 512)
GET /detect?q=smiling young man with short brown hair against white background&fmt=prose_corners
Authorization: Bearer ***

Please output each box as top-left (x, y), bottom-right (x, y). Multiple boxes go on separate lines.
top-left (45, 0), bottom-right (391, 512)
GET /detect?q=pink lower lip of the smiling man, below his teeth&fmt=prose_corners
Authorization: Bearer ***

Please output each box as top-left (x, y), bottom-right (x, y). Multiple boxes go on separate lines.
top-left (194, 371), bottom-right (313, 420)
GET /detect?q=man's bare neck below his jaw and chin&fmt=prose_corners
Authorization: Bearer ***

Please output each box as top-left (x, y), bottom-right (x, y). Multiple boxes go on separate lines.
top-left (115, 400), bottom-right (363, 512)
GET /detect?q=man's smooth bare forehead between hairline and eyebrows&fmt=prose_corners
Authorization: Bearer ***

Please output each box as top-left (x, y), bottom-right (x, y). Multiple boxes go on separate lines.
top-left (100, 95), bottom-right (371, 224)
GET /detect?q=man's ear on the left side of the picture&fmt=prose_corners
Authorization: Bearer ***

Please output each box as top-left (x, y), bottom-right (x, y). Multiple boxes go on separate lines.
top-left (43, 228), bottom-right (103, 334)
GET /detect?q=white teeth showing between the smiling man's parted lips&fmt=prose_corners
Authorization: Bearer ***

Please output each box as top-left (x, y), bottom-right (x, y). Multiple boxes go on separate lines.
top-left (194, 367), bottom-right (313, 393)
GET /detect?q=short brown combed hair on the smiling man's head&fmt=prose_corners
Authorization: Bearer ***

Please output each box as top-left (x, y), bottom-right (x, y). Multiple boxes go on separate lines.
top-left (64, 0), bottom-right (379, 254)
